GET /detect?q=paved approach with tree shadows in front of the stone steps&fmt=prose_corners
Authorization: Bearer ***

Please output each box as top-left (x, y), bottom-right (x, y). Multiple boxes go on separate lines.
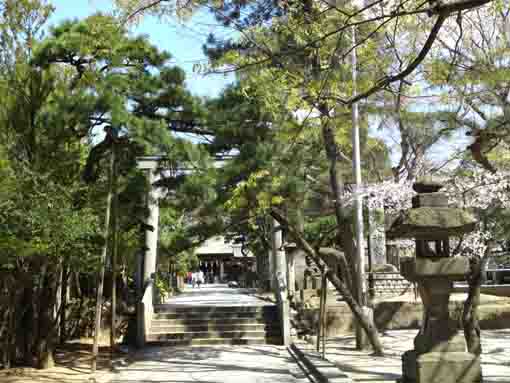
top-left (110, 345), bottom-right (302, 383)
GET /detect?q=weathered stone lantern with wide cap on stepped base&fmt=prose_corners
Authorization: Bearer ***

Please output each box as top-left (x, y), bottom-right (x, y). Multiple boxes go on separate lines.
top-left (388, 179), bottom-right (482, 383)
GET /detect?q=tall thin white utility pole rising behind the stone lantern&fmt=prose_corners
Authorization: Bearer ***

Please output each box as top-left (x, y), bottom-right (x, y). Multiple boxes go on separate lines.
top-left (352, 26), bottom-right (367, 349)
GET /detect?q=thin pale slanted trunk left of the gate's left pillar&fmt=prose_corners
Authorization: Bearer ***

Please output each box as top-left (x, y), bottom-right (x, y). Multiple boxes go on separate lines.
top-left (91, 148), bottom-right (115, 373)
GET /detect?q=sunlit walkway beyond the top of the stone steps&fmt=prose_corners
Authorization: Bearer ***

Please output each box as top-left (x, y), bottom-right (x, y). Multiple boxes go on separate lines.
top-left (165, 284), bottom-right (274, 306)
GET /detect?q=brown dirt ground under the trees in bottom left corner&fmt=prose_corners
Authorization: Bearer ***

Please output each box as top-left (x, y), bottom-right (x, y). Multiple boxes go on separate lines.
top-left (0, 342), bottom-right (118, 383)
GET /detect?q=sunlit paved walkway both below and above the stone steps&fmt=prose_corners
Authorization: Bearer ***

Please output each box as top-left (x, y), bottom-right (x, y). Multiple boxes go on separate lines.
top-left (109, 285), bottom-right (302, 383)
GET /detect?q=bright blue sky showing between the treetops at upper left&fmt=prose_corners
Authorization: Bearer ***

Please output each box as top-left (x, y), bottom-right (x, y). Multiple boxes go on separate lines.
top-left (50, 0), bottom-right (234, 97)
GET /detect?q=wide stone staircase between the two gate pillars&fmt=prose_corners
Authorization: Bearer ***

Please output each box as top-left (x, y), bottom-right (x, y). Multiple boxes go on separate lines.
top-left (146, 305), bottom-right (282, 346)
